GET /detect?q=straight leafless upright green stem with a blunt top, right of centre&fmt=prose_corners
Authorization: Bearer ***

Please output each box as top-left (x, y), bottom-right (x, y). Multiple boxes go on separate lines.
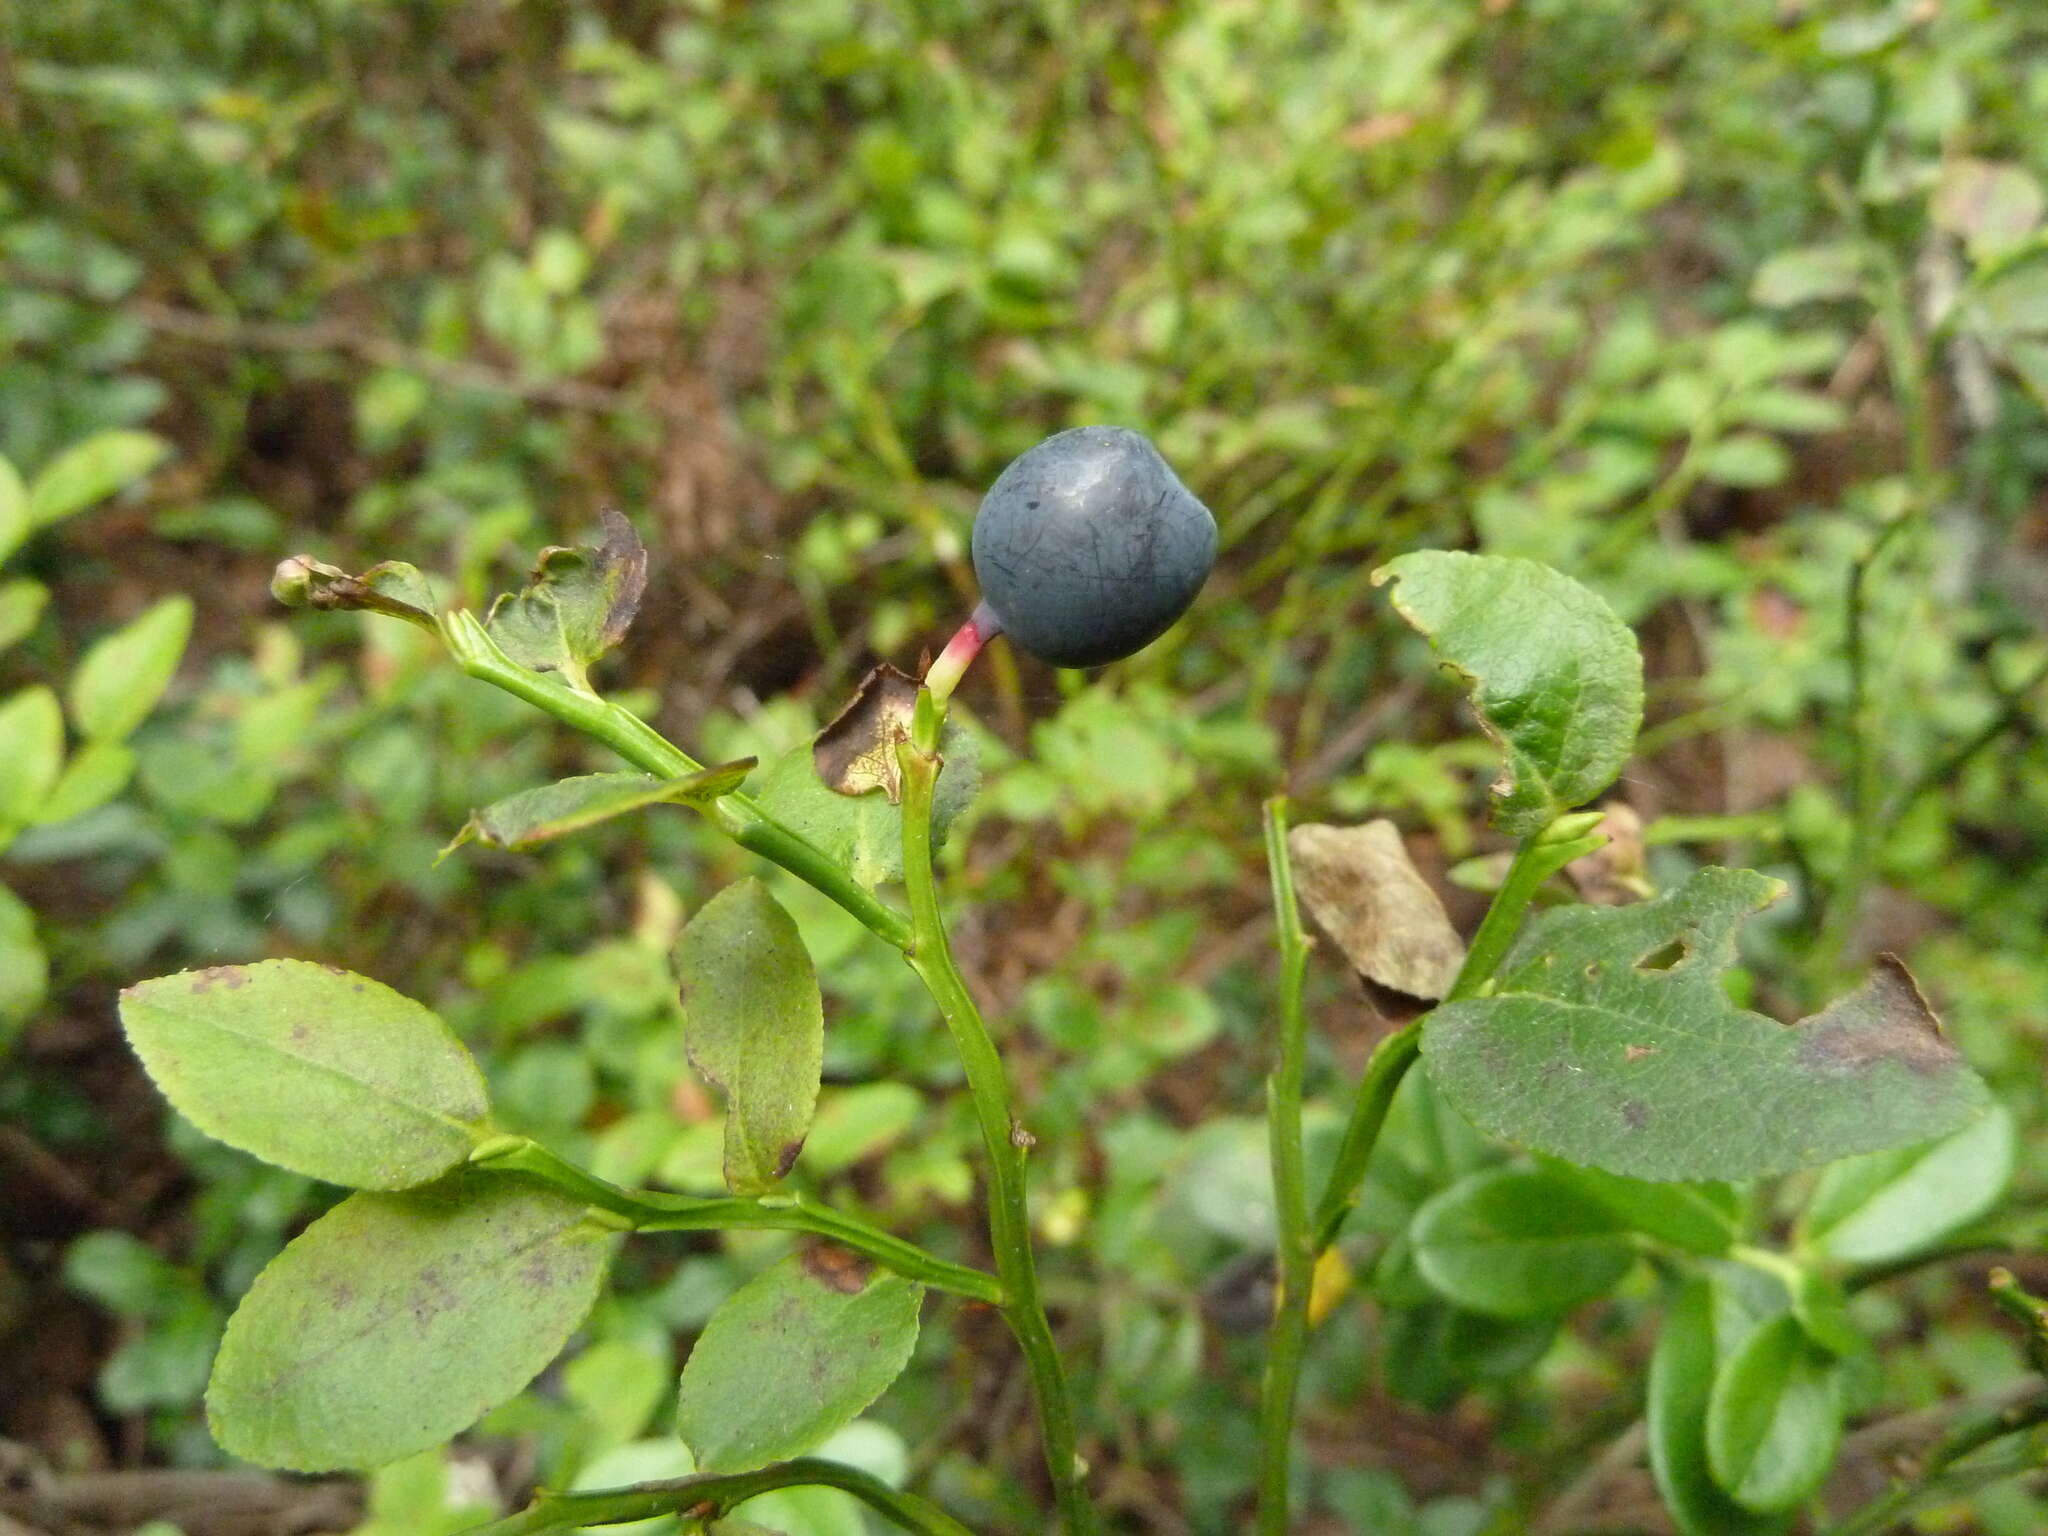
top-left (1257, 799), bottom-right (1317, 1536)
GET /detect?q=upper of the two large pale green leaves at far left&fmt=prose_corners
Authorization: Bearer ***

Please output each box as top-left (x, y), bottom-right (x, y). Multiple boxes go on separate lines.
top-left (121, 961), bottom-right (489, 1190)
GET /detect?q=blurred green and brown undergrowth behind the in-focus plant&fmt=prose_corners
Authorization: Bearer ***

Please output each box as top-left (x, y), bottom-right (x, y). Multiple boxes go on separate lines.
top-left (12, 0), bottom-right (2048, 1536)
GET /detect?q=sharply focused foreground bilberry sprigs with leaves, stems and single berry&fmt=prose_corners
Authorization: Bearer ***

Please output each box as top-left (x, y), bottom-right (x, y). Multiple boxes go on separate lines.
top-left (123, 428), bottom-right (2048, 1536)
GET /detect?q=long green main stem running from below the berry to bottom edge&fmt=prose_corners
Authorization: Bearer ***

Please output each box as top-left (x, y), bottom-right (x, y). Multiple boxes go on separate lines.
top-left (897, 690), bottom-right (1096, 1536)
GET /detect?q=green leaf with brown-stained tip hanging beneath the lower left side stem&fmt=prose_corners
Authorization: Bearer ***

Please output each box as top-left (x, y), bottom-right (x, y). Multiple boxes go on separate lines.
top-left (676, 1249), bottom-right (924, 1473)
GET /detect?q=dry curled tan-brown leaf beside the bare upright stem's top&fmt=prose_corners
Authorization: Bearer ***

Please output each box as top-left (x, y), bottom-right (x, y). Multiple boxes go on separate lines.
top-left (1288, 821), bottom-right (1464, 1001)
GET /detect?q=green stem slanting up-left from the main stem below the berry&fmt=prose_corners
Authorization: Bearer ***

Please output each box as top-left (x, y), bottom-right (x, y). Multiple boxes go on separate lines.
top-left (442, 610), bottom-right (909, 948)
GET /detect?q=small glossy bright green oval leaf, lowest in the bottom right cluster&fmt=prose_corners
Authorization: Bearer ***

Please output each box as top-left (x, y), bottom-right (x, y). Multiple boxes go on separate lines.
top-left (1706, 1315), bottom-right (1841, 1513)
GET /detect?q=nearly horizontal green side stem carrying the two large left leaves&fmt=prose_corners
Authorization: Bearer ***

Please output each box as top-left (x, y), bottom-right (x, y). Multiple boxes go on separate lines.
top-left (471, 1137), bottom-right (1004, 1307)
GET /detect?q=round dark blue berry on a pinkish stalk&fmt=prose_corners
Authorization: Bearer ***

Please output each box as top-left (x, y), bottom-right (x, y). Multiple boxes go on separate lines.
top-left (975, 426), bottom-right (1217, 668)
